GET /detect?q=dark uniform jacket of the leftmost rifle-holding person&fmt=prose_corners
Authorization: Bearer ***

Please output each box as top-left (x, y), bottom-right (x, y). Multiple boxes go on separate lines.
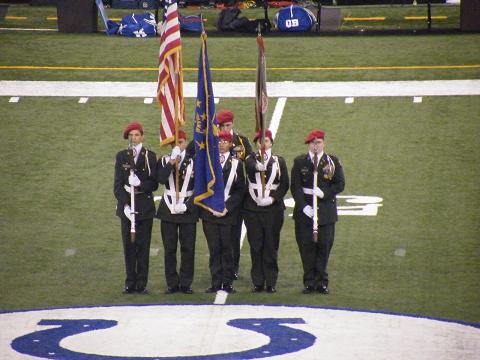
top-left (113, 147), bottom-right (158, 220)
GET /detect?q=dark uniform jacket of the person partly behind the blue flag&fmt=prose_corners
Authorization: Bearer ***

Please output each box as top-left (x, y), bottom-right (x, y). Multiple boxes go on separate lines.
top-left (200, 156), bottom-right (245, 225)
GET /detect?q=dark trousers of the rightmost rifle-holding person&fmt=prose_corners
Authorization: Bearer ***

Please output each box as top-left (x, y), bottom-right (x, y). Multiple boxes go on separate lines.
top-left (295, 220), bottom-right (335, 287)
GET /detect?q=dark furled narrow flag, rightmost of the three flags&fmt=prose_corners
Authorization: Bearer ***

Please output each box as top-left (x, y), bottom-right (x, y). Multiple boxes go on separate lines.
top-left (255, 34), bottom-right (268, 136)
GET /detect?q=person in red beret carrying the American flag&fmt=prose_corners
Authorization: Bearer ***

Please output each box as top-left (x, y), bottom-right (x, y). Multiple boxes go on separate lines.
top-left (156, 130), bottom-right (198, 294)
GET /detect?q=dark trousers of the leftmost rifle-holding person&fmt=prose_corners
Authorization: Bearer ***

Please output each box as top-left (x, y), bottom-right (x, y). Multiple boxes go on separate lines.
top-left (120, 218), bottom-right (153, 289)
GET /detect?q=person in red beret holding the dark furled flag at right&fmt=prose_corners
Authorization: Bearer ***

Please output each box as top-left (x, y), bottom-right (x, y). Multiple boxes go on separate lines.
top-left (244, 130), bottom-right (289, 293)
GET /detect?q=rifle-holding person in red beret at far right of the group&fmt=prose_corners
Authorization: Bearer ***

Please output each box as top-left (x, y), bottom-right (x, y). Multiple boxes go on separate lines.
top-left (290, 130), bottom-right (345, 294)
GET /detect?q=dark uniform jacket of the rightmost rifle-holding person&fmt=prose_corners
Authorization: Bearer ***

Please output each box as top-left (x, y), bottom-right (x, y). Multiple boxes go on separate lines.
top-left (290, 153), bottom-right (345, 225)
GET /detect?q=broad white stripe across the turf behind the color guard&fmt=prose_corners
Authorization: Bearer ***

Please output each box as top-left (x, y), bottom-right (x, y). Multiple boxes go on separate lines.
top-left (0, 80), bottom-right (480, 98)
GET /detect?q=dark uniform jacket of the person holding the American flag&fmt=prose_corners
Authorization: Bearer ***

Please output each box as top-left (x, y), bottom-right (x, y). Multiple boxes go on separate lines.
top-left (156, 153), bottom-right (199, 223)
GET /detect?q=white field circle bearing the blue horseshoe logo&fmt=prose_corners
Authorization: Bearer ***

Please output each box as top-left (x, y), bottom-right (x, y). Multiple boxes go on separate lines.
top-left (0, 305), bottom-right (480, 360)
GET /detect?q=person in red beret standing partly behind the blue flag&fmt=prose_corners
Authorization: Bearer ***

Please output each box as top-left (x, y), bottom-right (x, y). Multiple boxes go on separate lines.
top-left (200, 131), bottom-right (245, 293)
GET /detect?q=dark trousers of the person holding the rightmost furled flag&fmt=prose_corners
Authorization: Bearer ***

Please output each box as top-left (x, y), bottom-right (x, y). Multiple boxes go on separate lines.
top-left (244, 207), bottom-right (284, 286)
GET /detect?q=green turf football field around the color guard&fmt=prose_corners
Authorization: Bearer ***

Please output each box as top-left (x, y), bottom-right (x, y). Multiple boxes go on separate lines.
top-left (0, 3), bottom-right (480, 322)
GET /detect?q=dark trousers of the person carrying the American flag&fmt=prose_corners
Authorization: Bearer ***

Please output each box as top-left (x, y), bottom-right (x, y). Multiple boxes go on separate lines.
top-left (160, 220), bottom-right (197, 288)
